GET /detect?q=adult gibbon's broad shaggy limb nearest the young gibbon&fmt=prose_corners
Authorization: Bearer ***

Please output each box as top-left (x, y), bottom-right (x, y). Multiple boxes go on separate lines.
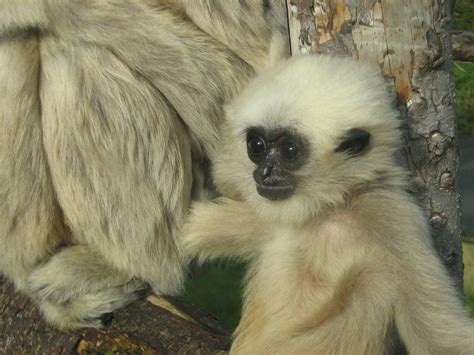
top-left (41, 38), bottom-right (192, 294)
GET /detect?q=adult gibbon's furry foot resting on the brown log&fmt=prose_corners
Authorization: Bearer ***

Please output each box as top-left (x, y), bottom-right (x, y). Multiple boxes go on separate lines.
top-left (26, 245), bottom-right (147, 329)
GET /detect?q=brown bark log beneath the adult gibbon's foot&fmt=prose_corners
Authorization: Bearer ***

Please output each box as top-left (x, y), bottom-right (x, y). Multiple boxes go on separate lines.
top-left (0, 277), bottom-right (230, 354)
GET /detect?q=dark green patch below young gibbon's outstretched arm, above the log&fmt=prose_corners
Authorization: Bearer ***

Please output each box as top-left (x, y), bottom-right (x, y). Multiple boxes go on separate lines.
top-left (182, 262), bottom-right (246, 330)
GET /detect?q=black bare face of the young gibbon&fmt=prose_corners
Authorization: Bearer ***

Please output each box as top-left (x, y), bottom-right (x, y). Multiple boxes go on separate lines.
top-left (247, 127), bottom-right (308, 201)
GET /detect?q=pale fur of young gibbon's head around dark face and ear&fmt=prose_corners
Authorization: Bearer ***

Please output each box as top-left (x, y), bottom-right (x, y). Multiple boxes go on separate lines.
top-left (214, 56), bottom-right (401, 222)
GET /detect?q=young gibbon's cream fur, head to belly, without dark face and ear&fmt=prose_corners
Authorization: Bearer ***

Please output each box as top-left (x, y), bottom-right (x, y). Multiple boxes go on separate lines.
top-left (184, 56), bottom-right (474, 354)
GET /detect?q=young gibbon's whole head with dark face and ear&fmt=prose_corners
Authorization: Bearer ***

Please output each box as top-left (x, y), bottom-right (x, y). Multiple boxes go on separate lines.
top-left (214, 56), bottom-right (400, 223)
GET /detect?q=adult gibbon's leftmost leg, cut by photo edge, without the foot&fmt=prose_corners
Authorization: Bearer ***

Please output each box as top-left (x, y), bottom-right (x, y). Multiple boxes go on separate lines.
top-left (0, 34), bottom-right (65, 292)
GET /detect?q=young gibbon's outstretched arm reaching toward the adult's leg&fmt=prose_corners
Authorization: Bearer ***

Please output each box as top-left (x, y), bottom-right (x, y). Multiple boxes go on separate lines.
top-left (184, 198), bottom-right (268, 262)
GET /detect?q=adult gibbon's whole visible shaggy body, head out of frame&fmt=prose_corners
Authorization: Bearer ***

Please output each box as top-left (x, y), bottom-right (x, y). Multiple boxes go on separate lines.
top-left (0, 0), bottom-right (284, 328)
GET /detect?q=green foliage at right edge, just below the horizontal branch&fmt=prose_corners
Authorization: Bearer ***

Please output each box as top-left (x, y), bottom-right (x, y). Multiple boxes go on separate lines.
top-left (454, 62), bottom-right (474, 135)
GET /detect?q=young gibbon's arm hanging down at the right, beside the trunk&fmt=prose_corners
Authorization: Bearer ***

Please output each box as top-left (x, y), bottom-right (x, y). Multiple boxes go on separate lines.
top-left (358, 196), bottom-right (474, 354)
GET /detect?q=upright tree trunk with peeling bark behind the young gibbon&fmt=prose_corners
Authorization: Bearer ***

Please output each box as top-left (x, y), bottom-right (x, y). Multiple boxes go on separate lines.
top-left (287, 0), bottom-right (463, 290)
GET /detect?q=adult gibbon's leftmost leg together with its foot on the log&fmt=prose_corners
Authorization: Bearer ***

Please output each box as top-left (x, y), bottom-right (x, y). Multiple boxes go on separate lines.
top-left (0, 36), bottom-right (143, 327)
